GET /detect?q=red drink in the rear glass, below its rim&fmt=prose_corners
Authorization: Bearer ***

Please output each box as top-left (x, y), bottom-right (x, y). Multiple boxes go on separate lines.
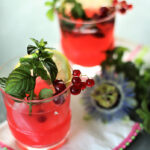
top-left (60, 17), bottom-right (115, 66)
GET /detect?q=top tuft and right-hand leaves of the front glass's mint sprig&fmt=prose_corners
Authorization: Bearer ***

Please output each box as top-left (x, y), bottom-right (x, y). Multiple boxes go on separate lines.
top-left (26, 38), bottom-right (58, 82)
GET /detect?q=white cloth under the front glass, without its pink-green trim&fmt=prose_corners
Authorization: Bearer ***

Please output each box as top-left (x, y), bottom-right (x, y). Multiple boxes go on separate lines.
top-left (0, 96), bottom-right (134, 150)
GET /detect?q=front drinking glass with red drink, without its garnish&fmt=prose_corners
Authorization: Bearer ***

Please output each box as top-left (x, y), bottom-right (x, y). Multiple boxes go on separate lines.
top-left (0, 60), bottom-right (71, 150)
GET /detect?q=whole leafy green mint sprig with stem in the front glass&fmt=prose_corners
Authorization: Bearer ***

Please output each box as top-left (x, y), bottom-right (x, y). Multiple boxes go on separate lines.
top-left (0, 38), bottom-right (58, 114)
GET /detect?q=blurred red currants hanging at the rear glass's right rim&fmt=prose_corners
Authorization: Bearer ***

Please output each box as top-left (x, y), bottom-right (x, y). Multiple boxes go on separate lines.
top-left (113, 0), bottom-right (133, 14)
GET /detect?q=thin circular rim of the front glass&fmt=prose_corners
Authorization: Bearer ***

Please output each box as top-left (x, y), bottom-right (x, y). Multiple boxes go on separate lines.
top-left (0, 56), bottom-right (72, 103)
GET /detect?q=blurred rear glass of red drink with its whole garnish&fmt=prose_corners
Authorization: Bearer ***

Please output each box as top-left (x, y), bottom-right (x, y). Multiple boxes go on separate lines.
top-left (46, 0), bottom-right (132, 67)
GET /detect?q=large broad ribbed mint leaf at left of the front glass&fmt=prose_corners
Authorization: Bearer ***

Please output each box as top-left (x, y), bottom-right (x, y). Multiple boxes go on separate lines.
top-left (5, 64), bottom-right (35, 98)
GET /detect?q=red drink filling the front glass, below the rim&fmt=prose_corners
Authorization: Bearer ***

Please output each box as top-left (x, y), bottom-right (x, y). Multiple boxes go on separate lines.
top-left (4, 78), bottom-right (71, 147)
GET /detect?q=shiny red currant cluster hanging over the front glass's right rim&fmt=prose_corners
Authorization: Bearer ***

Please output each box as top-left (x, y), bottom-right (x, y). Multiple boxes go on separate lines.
top-left (70, 70), bottom-right (95, 95)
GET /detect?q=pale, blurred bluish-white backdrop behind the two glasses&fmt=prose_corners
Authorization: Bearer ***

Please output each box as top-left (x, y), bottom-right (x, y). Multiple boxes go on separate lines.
top-left (0, 0), bottom-right (150, 65)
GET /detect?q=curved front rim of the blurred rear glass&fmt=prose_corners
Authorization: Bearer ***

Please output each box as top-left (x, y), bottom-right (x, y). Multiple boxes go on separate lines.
top-left (57, 10), bottom-right (116, 24)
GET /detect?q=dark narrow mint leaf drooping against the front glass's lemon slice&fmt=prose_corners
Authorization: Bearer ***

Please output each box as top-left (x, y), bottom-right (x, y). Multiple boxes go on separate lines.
top-left (42, 58), bottom-right (58, 82)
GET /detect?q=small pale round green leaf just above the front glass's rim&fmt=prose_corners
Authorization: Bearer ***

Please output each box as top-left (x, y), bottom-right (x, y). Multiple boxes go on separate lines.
top-left (39, 88), bottom-right (53, 99)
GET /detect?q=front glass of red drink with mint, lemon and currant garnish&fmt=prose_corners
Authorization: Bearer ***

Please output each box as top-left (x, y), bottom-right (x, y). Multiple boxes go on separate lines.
top-left (0, 39), bottom-right (94, 150)
